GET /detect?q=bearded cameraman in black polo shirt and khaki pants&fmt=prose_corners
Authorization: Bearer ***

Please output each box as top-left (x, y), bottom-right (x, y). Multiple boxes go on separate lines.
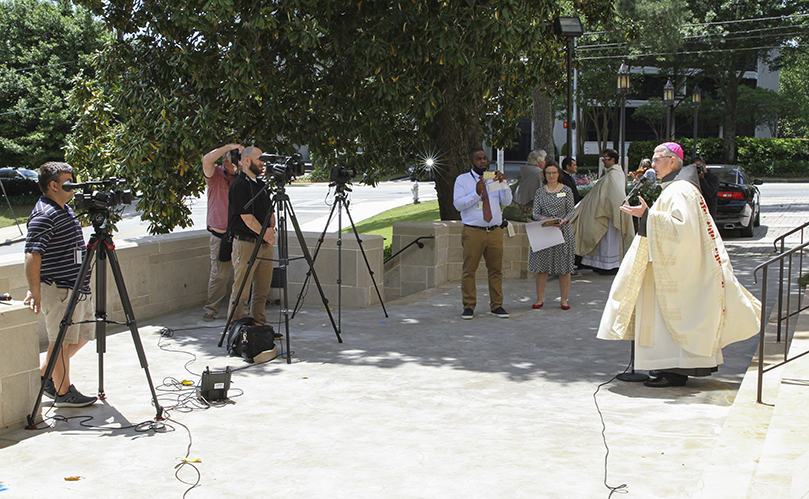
top-left (228, 147), bottom-right (275, 324)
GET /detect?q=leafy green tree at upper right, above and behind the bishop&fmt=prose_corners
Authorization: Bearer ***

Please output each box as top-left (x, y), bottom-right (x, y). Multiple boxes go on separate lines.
top-left (583, 0), bottom-right (809, 163)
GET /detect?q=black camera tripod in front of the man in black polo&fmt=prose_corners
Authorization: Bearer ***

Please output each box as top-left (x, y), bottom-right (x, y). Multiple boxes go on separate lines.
top-left (219, 176), bottom-right (343, 364)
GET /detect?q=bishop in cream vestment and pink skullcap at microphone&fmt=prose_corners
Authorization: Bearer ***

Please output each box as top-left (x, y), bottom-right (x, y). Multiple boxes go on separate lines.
top-left (598, 142), bottom-right (761, 387)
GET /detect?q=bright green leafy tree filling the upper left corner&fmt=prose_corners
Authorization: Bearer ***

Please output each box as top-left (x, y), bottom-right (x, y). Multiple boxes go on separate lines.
top-left (0, 0), bottom-right (105, 168)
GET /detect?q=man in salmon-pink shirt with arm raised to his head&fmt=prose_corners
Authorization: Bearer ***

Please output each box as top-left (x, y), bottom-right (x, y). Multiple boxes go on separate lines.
top-left (202, 144), bottom-right (244, 322)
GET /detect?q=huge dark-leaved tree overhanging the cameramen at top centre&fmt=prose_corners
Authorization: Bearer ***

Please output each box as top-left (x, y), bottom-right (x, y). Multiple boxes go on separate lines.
top-left (71, 0), bottom-right (609, 232)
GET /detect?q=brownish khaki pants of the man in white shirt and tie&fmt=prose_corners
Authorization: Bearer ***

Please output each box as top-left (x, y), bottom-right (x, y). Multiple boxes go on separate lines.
top-left (461, 225), bottom-right (503, 310)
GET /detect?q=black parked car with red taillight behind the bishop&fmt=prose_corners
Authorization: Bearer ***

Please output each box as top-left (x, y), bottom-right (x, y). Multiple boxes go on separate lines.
top-left (707, 165), bottom-right (763, 237)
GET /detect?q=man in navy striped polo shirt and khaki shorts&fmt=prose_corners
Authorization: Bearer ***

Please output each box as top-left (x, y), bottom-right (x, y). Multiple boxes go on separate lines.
top-left (24, 162), bottom-right (97, 407)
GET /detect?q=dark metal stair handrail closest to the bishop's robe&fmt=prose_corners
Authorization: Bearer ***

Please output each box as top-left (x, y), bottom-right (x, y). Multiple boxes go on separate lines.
top-left (753, 239), bottom-right (809, 404)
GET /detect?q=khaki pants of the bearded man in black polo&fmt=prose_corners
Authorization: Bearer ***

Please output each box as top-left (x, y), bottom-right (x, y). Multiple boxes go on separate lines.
top-left (228, 239), bottom-right (274, 324)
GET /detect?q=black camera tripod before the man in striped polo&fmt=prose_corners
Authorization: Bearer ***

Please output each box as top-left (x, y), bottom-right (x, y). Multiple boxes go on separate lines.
top-left (26, 208), bottom-right (163, 429)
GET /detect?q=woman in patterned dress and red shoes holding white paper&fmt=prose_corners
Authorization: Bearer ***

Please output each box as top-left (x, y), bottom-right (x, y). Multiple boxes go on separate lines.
top-left (528, 165), bottom-right (576, 310)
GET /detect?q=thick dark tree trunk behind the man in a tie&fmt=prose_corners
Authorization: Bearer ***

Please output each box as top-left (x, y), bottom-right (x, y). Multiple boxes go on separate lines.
top-left (425, 98), bottom-right (482, 220)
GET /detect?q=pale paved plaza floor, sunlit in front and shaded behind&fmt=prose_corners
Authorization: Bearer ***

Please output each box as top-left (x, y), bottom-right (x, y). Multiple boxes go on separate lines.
top-left (0, 243), bottom-right (800, 499)
